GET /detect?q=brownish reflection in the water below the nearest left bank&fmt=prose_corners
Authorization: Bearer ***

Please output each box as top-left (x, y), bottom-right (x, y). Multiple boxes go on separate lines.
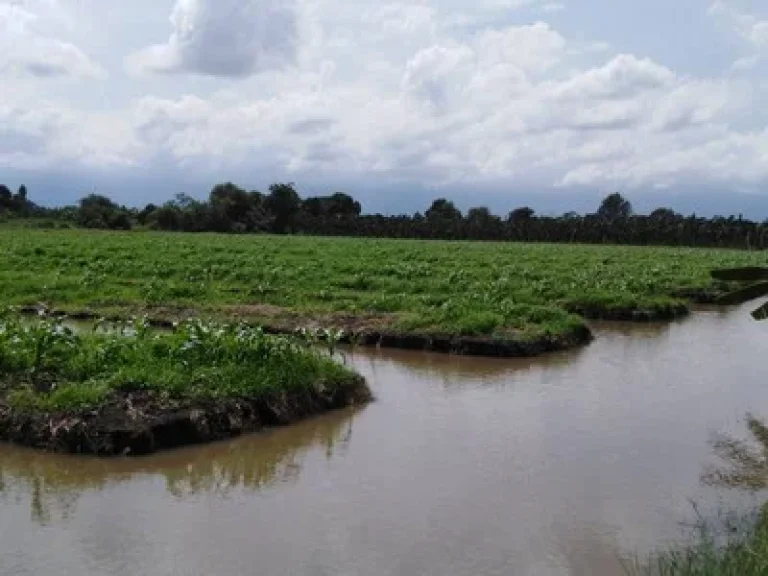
top-left (0, 409), bottom-right (359, 524)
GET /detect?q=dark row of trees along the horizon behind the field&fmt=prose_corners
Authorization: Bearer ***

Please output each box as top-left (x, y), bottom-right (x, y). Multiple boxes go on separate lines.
top-left (0, 183), bottom-right (768, 250)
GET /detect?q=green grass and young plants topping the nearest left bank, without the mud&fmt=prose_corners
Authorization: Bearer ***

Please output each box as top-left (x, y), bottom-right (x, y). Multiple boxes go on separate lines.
top-left (0, 313), bottom-right (357, 412)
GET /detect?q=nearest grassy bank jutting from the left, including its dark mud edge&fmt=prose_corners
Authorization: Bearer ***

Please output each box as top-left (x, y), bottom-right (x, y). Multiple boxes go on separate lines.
top-left (0, 313), bottom-right (369, 454)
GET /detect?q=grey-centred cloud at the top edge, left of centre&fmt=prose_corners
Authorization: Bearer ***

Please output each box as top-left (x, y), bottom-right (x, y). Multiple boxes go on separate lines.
top-left (128, 0), bottom-right (297, 77)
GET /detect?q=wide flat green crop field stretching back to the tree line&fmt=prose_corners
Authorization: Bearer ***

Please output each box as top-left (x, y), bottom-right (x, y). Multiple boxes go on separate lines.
top-left (0, 230), bottom-right (766, 339)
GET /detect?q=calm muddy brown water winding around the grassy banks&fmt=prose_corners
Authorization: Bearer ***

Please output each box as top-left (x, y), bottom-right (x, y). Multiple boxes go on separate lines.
top-left (0, 306), bottom-right (768, 576)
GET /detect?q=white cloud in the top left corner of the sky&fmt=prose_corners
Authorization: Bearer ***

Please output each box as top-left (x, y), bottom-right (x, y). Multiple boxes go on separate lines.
top-left (0, 0), bottom-right (104, 78)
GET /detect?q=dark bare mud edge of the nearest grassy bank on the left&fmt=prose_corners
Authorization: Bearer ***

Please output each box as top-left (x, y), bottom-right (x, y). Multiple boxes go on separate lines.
top-left (0, 377), bottom-right (372, 456)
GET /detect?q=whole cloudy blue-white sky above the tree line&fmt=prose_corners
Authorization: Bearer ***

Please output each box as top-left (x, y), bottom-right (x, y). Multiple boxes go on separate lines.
top-left (0, 0), bottom-right (768, 213)
